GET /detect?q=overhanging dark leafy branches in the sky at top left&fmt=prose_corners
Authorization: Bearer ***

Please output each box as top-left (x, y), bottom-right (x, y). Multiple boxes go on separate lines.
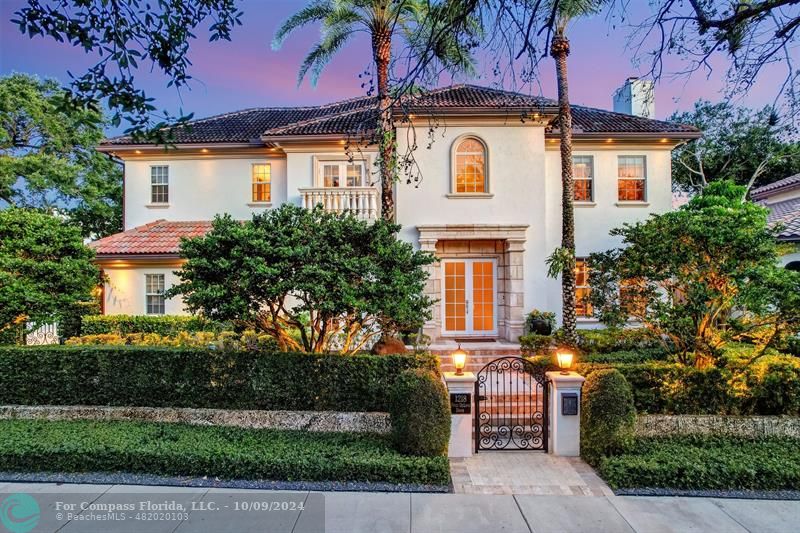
top-left (11, 0), bottom-right (242, 143)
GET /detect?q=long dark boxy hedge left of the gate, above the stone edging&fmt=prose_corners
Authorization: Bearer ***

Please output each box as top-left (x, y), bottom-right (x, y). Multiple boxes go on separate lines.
top-left (0, 346), bottom-right (438, 411)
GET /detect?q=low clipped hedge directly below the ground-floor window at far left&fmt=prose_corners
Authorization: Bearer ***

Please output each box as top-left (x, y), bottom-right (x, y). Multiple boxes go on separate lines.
top-left (82, 315), bottom-right (222, 336)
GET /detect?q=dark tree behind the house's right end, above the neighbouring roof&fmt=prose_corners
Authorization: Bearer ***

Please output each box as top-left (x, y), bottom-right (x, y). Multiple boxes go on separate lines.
top-left (669, 100), bottom-right (800, 192)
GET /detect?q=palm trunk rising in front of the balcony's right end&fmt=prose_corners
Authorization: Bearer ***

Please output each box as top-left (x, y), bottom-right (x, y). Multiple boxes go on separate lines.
top-left (372, 28), bottom-right (394, 220)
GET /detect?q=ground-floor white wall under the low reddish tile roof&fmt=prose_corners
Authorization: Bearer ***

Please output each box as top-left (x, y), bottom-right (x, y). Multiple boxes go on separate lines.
top-left (101, 265), bottom-right (186, 315)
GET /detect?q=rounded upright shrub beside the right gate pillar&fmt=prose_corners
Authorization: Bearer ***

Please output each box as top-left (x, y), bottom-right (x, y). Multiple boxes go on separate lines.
top-left (581, 368), bottom-right (636, 462)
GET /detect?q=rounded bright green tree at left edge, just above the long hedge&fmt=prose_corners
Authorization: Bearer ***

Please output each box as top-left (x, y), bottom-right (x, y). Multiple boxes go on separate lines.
top-left (0, 208), bottom-right (100, 333)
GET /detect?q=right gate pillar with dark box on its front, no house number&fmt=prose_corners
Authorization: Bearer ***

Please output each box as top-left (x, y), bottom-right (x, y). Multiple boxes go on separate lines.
top-left (547, 372), bottom-right (586, 457)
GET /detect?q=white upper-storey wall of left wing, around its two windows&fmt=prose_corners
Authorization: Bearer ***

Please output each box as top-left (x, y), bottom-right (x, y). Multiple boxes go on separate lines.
top-left (125, 152), bottom-right (286, 230)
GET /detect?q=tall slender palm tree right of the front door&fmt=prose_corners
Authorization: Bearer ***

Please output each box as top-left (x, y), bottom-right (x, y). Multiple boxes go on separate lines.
top-left (550, 0), bottom-right (608, 344)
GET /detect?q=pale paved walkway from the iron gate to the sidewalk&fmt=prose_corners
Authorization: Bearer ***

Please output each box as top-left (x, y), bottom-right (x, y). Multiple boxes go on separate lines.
top-left (450, 451), bottom-right (613, 496)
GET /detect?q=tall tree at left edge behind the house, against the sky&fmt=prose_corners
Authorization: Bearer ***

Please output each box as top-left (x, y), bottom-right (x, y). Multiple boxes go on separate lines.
top-left (0, 74), bottom-right (122, 237)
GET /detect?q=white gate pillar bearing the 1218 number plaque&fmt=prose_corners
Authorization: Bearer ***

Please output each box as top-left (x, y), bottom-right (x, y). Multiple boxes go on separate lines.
top-left (444, 372), bottom-right (477, 457)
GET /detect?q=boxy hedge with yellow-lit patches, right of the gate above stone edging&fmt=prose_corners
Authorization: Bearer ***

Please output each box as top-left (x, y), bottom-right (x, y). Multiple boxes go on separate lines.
top-left (577, 356), bottom-right (800, 416)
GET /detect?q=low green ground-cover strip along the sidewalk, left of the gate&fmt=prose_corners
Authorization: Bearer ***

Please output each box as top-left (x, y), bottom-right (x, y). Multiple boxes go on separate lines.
top-left (0, 420), bottom-right (450, 485)
